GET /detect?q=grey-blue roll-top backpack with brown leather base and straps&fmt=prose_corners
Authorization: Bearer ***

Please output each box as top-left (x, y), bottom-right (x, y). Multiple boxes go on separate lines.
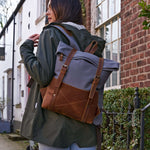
top-left (40, 25), bottom-right (117, 124)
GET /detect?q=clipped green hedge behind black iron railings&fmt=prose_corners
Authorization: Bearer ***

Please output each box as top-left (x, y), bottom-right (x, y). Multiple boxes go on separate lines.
top-left (102, 88), bottom-right (150, 150)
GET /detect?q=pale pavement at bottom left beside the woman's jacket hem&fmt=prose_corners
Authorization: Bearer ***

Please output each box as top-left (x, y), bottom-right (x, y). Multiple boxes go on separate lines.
top-left (0, 133), bottom-right (29, 150)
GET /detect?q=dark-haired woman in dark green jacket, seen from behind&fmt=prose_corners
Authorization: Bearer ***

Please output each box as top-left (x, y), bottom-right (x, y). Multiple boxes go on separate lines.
top-left (20, 0), bottom-right (105, 150)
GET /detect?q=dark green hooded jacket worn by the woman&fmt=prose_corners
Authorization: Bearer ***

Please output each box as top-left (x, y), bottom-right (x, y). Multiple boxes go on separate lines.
top-left (20, 23), bottom-right (105, 148)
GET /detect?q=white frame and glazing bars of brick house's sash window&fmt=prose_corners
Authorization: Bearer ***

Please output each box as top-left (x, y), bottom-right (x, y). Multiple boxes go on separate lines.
top-left (95, 0), bottom-right (121, 90)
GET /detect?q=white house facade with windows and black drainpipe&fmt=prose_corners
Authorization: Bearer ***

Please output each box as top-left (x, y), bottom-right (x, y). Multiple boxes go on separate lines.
top-left (0, 0), bottom-right (46, 131)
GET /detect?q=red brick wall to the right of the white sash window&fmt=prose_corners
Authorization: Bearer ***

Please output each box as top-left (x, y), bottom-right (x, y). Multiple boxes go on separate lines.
top-left (121, 0), bottom-right (150, 88)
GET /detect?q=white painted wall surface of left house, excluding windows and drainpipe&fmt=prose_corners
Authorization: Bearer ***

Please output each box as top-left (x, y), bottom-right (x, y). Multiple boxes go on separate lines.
top-left (0, 0), bottom-right (45, 124)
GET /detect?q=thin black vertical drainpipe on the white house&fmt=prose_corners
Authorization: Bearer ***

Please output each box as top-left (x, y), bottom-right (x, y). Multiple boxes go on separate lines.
top-left (10, 14), bottom-right (16, 132)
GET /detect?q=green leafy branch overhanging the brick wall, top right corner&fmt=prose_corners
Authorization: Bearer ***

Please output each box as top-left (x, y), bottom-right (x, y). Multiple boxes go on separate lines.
top-left (139, 0), bottom-right (150, 30)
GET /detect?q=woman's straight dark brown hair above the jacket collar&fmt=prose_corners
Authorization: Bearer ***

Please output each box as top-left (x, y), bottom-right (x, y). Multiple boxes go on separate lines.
top-left (50, 0), bottom-right (83, 24)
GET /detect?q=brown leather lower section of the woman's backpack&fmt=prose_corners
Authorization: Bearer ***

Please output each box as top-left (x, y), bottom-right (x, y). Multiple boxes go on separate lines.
top-left (40, 78), bottom-right (100, 124)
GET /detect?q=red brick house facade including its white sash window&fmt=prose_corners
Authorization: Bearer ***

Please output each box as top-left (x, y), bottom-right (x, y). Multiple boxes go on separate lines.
top-left (85, 0), bottom-right (150, 89)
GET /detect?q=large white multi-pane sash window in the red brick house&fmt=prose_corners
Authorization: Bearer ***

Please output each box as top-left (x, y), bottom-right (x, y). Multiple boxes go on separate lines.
top-left (96, 0), bottom-right (121, 88)
